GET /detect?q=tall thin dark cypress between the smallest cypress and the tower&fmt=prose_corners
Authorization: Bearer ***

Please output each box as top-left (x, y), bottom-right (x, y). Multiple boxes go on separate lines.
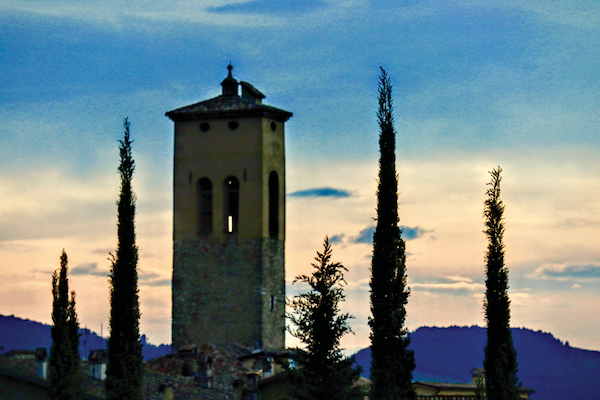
top-left (105, 118), bottom-right (144, 400)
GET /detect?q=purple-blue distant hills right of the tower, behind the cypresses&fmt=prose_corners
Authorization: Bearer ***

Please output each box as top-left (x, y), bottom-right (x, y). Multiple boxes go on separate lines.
top-left (355, 326), bottom-right (600, 400)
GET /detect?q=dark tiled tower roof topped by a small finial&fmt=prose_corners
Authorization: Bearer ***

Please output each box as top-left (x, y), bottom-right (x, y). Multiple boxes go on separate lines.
top-left (166, 64), bottom-right (293, 122)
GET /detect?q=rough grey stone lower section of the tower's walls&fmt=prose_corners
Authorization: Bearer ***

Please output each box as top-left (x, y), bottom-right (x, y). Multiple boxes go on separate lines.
top-left (172, 238), bottom-right (285, 350)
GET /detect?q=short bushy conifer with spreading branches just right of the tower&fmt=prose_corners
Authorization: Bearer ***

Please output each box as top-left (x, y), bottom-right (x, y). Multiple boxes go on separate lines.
top-left (288, 237), bottom-right (362, 400)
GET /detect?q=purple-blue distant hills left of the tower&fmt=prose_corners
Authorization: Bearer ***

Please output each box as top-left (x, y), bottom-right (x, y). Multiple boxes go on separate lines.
top-left (0, 315), bottom-right (171, 360)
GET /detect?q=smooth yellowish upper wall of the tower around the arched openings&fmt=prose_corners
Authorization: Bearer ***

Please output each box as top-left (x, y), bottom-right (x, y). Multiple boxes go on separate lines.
top-left (173, 117), bottom-right (285, 241)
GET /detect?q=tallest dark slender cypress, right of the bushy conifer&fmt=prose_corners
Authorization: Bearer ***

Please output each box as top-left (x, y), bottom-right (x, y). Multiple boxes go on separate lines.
top-left (369, 68), bottom-right (416, 400)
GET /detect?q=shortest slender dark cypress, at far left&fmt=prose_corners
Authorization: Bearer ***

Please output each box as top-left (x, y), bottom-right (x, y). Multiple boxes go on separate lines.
top-left (48, 249), bottom-right (83, 400)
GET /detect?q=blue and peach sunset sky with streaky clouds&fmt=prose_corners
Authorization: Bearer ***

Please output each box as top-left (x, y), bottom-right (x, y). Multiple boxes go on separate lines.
top-left (0, 0), bottom-right (600, 353)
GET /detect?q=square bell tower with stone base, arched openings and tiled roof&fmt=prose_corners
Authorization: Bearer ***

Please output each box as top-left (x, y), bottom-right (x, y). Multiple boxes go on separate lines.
top-left (166, 65), bottom-right (292, 350)
